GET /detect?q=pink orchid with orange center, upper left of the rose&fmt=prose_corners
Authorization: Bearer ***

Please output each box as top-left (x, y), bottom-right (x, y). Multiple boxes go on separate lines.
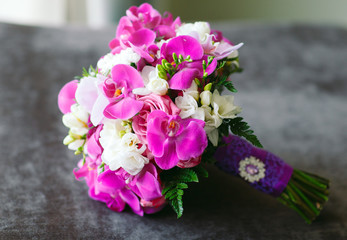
top-left (103, 64), bottom-right (144, 119)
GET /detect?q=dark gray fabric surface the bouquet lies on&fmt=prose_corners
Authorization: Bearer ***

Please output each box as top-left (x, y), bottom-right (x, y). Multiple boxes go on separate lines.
top-left (0, 23), bottom-right (347, 240)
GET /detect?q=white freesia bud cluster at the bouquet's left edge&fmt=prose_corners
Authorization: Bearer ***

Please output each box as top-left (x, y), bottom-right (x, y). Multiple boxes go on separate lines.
top-left (63, 103), bottom-right (89, 150)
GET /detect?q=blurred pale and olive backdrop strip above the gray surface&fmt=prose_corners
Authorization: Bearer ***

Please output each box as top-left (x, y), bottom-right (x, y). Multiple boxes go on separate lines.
top-left (0, 0), bottom-right (347, 28)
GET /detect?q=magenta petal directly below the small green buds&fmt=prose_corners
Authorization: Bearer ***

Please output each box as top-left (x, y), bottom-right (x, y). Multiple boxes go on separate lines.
top-left (169, 68), bottom-right (200, 90)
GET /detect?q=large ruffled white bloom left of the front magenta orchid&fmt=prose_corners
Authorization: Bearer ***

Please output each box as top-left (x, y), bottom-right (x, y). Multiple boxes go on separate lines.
top-left (100, 119), bottom-right (149, 175)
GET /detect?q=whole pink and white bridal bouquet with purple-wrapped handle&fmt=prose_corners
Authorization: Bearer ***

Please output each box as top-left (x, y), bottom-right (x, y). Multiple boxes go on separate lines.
top-left (58, 3), bottom-right (329, 222)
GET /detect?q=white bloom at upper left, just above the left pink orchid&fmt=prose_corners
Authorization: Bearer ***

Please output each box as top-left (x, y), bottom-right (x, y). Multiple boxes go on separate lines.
top-left (97, 48), bottom-right (141, 75)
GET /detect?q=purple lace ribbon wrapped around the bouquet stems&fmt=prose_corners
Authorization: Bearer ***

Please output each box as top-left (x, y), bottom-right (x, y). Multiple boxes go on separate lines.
top-left (215, 135), bottom-right (293, 197)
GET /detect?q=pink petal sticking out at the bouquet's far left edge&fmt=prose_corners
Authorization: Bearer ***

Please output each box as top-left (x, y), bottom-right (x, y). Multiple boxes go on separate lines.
top-left (58, 80), bottom-right (78, 114)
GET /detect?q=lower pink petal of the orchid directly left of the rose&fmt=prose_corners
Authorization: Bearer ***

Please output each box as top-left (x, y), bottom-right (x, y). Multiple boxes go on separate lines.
top-left (104, 97), bottom-right (143, 120)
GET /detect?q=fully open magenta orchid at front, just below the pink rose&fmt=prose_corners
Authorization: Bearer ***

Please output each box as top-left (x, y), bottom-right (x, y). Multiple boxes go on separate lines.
top-left (147, 110), bottom-right (208, 169)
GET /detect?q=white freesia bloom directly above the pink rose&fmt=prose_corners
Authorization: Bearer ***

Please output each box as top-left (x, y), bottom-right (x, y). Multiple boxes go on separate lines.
top-left (133, 66), bottom-right (169, 95)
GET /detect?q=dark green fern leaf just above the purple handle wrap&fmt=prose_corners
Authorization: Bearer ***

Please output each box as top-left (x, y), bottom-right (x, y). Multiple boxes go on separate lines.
top-left (227, 117), bottom-right (263, 148)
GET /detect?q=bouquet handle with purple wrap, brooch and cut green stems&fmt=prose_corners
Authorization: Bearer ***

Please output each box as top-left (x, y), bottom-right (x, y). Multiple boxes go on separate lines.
top-left (215, 135), bottom-right (329, 223)
